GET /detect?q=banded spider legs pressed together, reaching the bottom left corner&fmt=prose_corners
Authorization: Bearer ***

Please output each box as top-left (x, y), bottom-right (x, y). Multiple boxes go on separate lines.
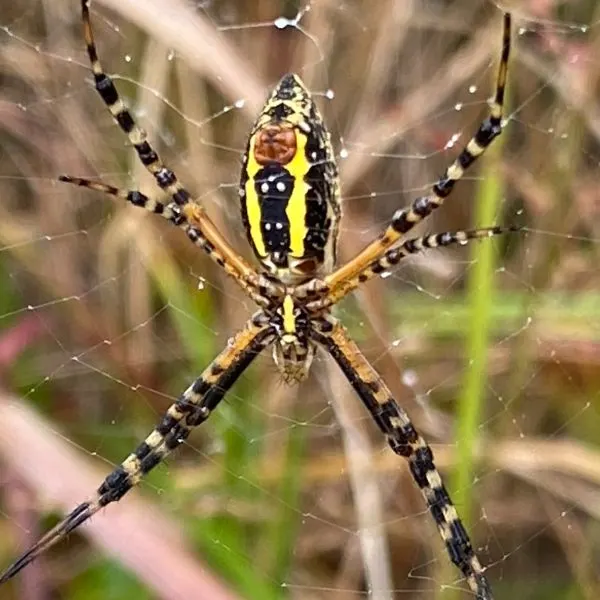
top-left (0, 312), bottom-right (275, 584)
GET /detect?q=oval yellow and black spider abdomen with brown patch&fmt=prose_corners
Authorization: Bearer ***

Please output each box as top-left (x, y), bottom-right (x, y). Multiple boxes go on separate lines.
top-left (240, 75), bottom-right (341, 283)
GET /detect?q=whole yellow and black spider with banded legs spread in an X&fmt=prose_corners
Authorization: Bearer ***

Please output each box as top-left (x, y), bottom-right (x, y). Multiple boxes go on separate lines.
top-left (0, 0), bottom-right (518, 600)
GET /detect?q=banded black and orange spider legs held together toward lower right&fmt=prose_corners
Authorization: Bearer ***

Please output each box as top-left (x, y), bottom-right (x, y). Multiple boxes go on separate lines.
top-left (313, 317), bottom-right (493, 600)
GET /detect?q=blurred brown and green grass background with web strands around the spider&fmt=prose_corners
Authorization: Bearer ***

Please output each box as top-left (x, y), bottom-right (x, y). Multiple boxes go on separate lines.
top-left (0, 0), bottom-right (600, 600)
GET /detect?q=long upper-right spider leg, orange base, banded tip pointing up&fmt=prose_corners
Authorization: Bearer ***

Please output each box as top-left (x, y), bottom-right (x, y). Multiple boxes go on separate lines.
top-left (307, 13), bottom-right (511, 304)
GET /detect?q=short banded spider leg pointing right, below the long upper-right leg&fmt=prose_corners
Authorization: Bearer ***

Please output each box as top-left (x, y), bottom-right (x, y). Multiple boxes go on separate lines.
top-left (306, 226), bottom-right (522, 312)
